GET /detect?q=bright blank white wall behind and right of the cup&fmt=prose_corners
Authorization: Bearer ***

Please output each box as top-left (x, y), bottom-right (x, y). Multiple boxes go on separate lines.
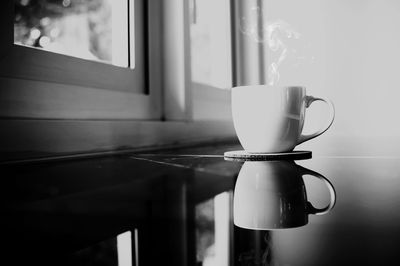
top-left (264, 0), bottom-right (400, 141)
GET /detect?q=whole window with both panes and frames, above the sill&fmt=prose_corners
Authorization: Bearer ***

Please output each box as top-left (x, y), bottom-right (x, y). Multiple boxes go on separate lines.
top-left (0, 0), bottom-right (236, 121)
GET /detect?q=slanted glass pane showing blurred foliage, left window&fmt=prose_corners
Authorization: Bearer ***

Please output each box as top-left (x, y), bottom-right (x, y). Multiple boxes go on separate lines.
top-left (14, 0), bottom-right (129, 67)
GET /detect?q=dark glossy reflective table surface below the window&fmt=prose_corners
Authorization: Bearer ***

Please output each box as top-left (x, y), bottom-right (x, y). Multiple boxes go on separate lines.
top-left (1, 145), bottom-right (400, 266)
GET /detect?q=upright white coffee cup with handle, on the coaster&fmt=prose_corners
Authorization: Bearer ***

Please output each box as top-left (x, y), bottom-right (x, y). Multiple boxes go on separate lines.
top-left (232, 85), bottom-right (335, 153)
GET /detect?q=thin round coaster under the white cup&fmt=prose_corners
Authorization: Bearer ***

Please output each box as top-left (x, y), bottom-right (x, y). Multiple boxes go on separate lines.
top-left (224, 150), bottom-right (312, 161)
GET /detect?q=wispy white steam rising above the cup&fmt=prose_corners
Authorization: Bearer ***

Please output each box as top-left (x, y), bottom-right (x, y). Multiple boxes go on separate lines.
top-left (240, 7), bottom-right (313, 85)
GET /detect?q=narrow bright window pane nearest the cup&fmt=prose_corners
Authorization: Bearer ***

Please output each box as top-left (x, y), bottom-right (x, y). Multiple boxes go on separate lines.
top-left (190, 0), bottom-right (231, 89)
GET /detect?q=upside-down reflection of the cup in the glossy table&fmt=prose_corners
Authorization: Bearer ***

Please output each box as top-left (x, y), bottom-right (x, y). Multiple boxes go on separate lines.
top-left (233, 161), bottom-right (336, 230)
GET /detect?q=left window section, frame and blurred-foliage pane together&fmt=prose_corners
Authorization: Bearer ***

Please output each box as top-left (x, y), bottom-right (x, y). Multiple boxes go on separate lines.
top-left (0, 0), bottom-right (161, 119)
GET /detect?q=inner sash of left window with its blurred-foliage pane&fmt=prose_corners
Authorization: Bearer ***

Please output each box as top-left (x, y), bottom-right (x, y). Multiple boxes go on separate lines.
top-left (2, 0), bottom-right (146, 92)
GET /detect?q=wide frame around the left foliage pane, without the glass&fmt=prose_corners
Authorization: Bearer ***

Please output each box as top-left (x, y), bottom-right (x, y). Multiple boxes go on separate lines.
top-left (0, 0), bottom-right (162, 120)
